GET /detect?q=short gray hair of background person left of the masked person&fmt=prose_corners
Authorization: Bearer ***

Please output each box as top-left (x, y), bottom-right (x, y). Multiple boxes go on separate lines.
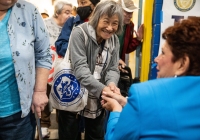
top-left (53, 1), bottom-right (72, 18)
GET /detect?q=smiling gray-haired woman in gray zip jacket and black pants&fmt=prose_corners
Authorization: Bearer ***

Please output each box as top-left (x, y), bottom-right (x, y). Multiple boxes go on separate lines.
top-left (59, 0), bottom-right (123, 140)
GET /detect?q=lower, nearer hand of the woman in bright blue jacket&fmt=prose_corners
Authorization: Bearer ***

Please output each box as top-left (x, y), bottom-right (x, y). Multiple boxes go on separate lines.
top-left (101, 95), bottom-right (122, 112)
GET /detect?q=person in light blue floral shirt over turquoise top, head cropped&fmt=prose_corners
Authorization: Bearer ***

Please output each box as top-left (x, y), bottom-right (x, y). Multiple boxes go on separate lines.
top-left (0, 0), bottom-right (51, 140)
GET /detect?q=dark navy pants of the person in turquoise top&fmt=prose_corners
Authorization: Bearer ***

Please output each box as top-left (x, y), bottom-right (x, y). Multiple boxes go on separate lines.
top-left (0, 112), bottom-right (36, 140)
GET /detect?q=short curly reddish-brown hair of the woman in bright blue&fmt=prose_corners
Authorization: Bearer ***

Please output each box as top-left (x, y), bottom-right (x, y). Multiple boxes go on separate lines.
top-left (162, 17), bottom-right (200, 75)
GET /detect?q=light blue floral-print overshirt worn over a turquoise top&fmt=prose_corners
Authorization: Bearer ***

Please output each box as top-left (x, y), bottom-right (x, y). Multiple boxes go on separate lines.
top-left (7, 0), bottom-right (52, 117)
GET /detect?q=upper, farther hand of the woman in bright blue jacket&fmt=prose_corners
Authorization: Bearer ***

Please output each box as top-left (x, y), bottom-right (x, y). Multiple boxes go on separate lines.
top-left (102, 92), bottom-right (127, 107)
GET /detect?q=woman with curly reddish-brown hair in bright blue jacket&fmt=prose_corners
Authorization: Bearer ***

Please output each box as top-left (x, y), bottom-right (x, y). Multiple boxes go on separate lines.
top-left (101, 17), bottom-right (200, 140)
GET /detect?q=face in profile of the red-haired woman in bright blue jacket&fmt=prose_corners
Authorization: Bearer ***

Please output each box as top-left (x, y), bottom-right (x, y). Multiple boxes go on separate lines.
top-left (154, 41), bottom-right (179, 78)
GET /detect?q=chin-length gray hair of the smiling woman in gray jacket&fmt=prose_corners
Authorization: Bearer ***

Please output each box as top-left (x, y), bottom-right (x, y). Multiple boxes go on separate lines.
top-left (89, 0), bottom-right (124, 34)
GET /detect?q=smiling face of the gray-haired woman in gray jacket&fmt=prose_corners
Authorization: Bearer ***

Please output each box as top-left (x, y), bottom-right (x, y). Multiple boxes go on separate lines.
top-left (96, 15), bottom-right (119, 43)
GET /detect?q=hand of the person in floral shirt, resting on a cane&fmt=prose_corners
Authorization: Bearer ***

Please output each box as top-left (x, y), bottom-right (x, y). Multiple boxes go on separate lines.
top-left (31, 91), bottom-right (48, 118)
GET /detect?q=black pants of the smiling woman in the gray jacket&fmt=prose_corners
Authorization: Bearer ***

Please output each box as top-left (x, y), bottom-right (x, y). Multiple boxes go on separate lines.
top-left (58, 110), bottom-right (105, 140)
